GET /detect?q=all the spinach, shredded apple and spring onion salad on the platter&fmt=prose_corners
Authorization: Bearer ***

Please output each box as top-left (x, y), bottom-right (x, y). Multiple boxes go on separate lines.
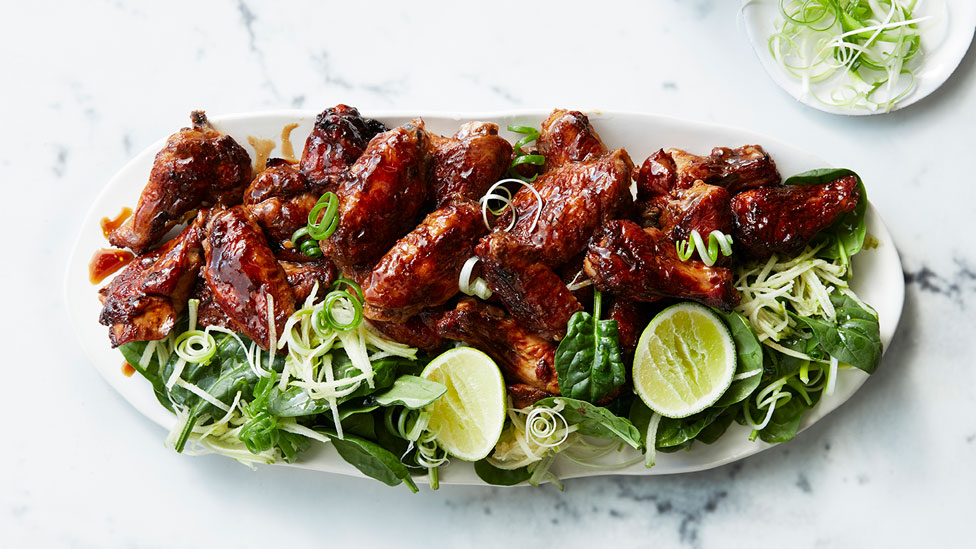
top-left (120, 164), bottom-right (882, 491)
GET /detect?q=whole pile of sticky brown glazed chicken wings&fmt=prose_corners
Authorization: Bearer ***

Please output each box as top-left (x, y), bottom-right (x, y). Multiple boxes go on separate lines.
top-left (99, 105), bottom-right (860, 407)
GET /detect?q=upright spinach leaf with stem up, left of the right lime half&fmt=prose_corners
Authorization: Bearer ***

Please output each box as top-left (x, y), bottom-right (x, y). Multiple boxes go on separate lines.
top-left (555, 292), bottom-right (627, 402)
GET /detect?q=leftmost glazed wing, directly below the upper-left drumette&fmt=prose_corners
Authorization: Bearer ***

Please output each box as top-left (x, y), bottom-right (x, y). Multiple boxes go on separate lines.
top-left (98, 213), bottom-right (204, 347)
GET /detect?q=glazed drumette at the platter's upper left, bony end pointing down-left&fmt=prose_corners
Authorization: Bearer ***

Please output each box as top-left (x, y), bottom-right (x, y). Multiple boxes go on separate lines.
top-left (109, 111), bottom-right (251, 254)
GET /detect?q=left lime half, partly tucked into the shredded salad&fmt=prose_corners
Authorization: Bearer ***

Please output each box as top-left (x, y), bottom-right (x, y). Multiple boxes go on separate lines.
top-left (420, 347), bottom-right (506, 461)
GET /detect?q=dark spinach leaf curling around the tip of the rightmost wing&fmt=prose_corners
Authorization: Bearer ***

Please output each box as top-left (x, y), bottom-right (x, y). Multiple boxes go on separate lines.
top-left (783, 168), bottom-right (868, 259)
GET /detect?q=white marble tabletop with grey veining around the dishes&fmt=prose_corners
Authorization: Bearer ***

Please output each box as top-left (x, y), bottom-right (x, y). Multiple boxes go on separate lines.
top-left (0, 0), bottom-right (976, 547)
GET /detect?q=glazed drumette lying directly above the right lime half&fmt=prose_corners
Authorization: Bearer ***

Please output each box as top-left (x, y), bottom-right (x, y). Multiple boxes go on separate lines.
top-left (584, 220), bottom-right (739, 311)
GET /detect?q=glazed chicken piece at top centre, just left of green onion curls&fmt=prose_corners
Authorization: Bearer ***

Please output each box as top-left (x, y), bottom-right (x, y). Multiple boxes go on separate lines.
top-left (430, 122), bottom-right (512, 207)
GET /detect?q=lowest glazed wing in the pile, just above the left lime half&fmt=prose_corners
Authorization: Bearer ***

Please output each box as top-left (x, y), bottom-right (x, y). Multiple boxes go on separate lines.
top-left (437, 298), bottom-right (559, 395)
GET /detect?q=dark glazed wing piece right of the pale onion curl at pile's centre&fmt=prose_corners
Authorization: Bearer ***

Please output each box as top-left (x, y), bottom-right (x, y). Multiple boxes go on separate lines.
top-left (475, 233), bottom-right (583, 341)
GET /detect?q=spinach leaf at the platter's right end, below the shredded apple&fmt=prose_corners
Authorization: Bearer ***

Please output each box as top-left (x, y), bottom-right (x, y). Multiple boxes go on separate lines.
top-left (793, 295), bottom-right (882, 374)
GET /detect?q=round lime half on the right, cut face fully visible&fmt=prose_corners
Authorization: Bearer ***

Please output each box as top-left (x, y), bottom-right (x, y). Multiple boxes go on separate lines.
top-left (633, 303), bottom-right (736, 418)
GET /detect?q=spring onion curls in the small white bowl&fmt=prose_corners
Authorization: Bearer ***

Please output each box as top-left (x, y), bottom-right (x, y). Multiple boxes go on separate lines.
top-left (769, 0), bottom-right (932, 112)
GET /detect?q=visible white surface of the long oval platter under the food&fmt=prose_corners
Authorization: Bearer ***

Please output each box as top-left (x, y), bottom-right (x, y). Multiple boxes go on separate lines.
top-left (65, 111), bottom-right (905, 484)
